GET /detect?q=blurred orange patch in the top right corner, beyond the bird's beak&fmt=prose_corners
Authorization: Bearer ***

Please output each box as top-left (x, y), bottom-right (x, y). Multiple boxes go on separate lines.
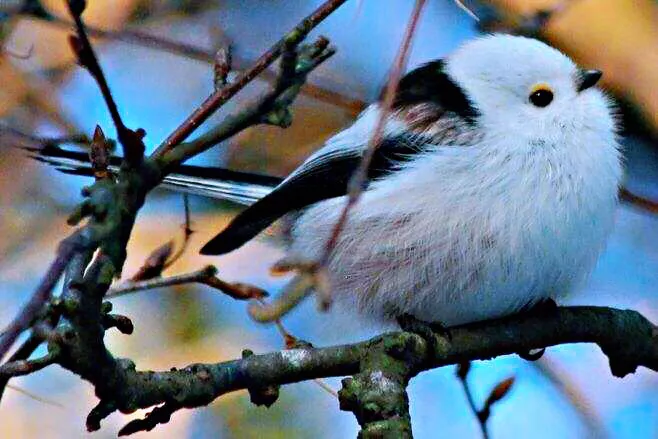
top-left (490, 0), bottom-right (658, 132)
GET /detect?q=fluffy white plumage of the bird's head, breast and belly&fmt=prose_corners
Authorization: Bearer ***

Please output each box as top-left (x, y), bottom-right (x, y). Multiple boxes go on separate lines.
top-left (291, 36), bottom-right (621, 326)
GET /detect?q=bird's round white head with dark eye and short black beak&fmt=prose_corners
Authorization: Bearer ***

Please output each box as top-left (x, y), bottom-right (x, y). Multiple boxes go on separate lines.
top-left (445, 35), bottom-right (615, 147)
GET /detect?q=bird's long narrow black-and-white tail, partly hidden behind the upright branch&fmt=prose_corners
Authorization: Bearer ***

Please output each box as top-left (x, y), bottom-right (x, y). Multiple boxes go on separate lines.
top-left (25, 146), bottom-right (281, 206)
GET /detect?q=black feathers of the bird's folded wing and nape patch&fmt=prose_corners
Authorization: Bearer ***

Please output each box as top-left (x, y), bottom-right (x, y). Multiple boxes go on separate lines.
top-left (201, 60), bottom-right (478, 255)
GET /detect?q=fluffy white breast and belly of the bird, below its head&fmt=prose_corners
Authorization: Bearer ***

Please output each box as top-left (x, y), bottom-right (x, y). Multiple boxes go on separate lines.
top-left (291, 112), bottom-right (621, 325)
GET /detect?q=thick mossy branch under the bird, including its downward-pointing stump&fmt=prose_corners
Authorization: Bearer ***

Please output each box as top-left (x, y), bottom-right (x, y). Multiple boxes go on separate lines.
top-left (9, 306), bottom-right (658, 437)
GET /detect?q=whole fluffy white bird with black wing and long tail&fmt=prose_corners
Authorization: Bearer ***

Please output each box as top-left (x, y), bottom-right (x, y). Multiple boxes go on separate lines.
top-left (29, 34), bottom-right (623, 327)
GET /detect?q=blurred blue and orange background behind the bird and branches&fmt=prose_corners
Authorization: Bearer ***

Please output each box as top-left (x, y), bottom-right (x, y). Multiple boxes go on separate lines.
top-left (0, 0), bottom-right (658, 438)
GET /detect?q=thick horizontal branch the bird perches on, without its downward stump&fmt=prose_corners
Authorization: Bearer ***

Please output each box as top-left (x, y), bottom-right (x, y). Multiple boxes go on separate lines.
top-left (50, 307), bottom-right (658, 434)
